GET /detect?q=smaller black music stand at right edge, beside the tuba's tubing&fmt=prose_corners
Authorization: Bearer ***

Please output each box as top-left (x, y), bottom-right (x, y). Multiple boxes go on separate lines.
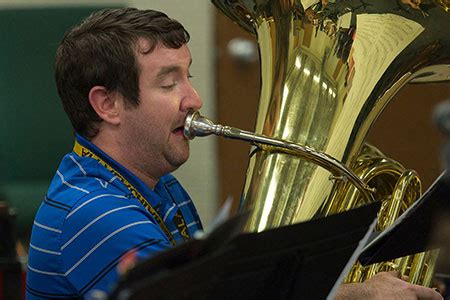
top-left (359, 171), bottom-right (450, 265)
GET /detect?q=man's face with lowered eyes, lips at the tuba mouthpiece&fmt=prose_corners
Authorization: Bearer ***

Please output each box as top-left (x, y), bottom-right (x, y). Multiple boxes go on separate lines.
top-left (121, 40), bottom-right (202, 176)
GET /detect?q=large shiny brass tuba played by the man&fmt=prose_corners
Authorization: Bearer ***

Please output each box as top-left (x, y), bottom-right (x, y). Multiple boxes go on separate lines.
top-left (198, 0), bottom-right (450, 286)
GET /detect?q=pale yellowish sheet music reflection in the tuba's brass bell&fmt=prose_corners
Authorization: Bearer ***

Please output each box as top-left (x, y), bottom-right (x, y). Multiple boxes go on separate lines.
top-left (325, 14), bottom-right (424, 162)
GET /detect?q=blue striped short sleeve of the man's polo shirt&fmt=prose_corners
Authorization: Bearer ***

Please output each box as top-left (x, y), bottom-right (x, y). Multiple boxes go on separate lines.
top-left (60, 192), bottom-right (171, 295)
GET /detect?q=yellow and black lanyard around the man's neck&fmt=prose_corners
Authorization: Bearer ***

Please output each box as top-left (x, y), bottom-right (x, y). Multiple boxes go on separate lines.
top-left (73, 141), bottom-right (190, 245)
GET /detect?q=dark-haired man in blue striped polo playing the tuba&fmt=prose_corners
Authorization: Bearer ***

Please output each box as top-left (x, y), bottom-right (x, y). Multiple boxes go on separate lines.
top-left (26, 8), bottom-right (441, 299)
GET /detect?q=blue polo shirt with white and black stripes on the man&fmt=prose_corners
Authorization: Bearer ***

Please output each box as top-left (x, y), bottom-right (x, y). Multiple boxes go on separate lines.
top-left (26, 135), bottom-right (202, 299)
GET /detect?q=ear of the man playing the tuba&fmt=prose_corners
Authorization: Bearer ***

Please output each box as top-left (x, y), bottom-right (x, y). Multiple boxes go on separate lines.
top-left (89, 86), bottom-right (121, 125)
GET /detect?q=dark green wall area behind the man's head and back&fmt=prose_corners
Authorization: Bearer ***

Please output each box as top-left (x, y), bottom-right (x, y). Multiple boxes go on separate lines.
top-left (0, 7), bottom-right (108, 237)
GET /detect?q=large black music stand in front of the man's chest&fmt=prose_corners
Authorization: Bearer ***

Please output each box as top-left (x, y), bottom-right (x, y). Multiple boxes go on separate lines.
top-left (111, 203), bottom-right (379, 300)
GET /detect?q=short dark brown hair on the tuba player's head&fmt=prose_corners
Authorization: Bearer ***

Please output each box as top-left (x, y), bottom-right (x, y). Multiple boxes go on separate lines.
top-left (55, 8), bottom-right (189, 138)
